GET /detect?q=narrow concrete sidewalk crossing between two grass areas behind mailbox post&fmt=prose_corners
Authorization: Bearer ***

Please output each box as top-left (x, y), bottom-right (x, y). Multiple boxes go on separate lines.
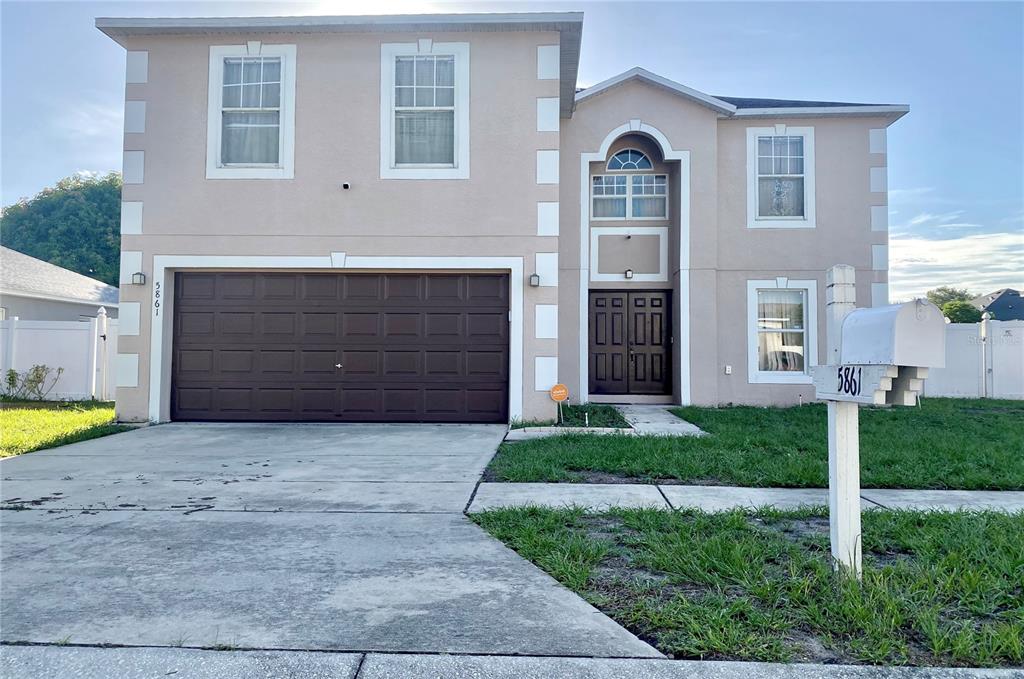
top-left (469, 483), bottom-right (1024, 512)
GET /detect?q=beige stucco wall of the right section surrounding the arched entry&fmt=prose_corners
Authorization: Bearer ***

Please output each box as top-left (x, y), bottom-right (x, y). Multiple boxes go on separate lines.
top-left (559, 81), bottom-right (891, 405)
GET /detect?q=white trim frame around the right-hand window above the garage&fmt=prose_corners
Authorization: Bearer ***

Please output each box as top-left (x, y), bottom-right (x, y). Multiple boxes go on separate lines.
top-left (381, 40), bottom-right (469, 179)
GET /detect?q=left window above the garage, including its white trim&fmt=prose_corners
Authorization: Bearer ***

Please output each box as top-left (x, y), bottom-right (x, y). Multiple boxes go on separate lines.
top-left (206, 41), bottom-right (296, 179)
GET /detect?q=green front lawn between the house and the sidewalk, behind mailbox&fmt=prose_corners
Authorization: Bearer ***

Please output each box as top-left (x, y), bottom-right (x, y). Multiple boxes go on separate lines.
top-left (487, 398), bottom-right (1024, 490)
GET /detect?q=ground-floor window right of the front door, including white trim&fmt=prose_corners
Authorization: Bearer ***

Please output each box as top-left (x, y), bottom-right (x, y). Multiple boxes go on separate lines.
top-left (748, 279), bottom-right (817, 383)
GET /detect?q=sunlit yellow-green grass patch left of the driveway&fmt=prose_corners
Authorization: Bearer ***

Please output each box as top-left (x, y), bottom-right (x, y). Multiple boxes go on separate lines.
top-left (0, 401), bottom-right (131, 458)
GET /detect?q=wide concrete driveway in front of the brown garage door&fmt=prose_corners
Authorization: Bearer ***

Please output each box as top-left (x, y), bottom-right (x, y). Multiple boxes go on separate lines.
top-left (0, 424), bottom-right (657, 656)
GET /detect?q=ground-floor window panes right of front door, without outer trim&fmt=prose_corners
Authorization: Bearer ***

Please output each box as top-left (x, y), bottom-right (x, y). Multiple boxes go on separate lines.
top-left (757, 289), bottom-right (807, 373)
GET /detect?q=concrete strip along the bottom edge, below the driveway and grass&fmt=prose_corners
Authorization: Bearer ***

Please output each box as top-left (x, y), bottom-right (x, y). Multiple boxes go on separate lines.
top-left (0, 646), bottom-right (1024, 679)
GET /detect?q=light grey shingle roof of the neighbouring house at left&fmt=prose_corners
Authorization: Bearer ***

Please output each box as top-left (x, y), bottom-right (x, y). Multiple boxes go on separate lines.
top-left (0, 247), bottom-right (119, 306)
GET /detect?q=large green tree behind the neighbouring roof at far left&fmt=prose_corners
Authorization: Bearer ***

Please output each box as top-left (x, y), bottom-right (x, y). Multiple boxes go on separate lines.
top-left (0, 172), bottom-right (121, 286)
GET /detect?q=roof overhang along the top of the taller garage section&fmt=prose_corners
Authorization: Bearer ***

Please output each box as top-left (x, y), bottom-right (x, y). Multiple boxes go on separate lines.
top-left (96, 12), bottom-right (583, 118)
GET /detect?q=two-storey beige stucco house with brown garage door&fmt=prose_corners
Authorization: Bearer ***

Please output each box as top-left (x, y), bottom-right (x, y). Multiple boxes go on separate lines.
top-left (96, 13), bottom-right (908, 422)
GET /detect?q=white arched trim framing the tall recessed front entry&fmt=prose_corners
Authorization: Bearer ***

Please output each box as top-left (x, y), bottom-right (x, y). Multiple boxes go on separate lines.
top-left (579, 119), bottom-right (692, 406)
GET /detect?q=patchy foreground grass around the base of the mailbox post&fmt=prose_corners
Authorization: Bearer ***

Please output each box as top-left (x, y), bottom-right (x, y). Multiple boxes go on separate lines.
top-left (472, 508), bottom-right (1024, 666)
